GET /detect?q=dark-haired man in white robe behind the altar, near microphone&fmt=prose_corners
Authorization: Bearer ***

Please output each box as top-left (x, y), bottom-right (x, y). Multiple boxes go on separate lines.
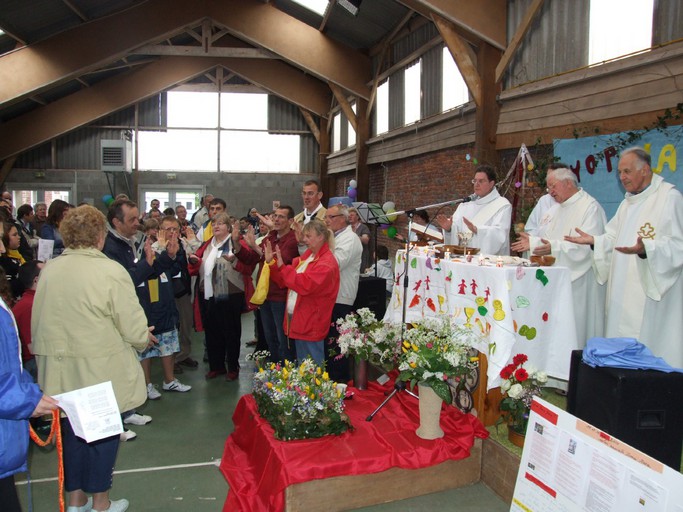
top-left (436, 165), bottom-right (512, 256)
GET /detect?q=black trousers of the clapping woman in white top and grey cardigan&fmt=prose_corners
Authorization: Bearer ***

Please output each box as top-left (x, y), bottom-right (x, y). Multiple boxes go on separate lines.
top-left (200, 293), bottom-right (244, 372)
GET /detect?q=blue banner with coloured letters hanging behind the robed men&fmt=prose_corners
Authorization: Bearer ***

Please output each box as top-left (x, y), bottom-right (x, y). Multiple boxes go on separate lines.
top-left (553, 126), bottom-right (683, 219)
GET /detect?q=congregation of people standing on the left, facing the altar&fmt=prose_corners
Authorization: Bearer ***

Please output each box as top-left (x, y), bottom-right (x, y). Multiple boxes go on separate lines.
top-left (0, 177), bottom-right (393, 512)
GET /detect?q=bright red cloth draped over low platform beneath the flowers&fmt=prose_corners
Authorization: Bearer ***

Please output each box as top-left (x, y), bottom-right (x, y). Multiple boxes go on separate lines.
top-left (220, 381), bottom-right (489, 512)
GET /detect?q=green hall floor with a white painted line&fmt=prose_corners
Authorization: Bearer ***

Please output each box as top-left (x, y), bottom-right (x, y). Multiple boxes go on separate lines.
top-left (16, 314), bottom-right (509, 512)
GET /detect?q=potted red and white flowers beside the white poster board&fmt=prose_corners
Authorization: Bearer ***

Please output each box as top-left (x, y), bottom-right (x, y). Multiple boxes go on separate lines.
top-left (498, 354), bottom-right (548, 435)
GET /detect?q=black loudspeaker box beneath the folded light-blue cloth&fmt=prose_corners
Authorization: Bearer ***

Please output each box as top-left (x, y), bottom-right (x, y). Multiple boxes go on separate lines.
top-left (567, 350), bottom-right (683, 471)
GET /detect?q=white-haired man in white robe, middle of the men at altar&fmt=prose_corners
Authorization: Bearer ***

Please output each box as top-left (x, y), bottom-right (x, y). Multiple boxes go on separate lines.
top-left (512, 168), bottom-right (607, 346)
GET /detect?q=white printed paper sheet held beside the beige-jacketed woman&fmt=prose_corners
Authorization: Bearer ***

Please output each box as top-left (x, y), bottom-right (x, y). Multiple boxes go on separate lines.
top-left (53, 381), bottom-right (123, 443)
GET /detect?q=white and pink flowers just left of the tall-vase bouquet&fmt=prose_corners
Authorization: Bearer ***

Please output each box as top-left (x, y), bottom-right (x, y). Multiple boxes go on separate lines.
top-left (336, 308), bottom-right (401, 368)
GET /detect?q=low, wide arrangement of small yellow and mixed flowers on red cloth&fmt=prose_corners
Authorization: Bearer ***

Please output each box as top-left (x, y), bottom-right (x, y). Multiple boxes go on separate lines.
top-left (253, 358), bottom-right (351, 441)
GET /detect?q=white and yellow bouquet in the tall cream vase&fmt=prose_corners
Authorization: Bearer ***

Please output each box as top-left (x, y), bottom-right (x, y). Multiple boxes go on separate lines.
top-left (398, 318), bottom-right (479, 403)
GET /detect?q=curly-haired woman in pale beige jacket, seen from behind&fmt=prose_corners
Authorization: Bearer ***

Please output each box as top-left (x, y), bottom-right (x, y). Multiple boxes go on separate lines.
top-left (32, 205), bottom-right (156, 512)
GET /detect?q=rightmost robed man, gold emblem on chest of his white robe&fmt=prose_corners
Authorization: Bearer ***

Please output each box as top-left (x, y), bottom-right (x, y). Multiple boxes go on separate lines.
top-left (566, 148), bottom-right (683, 368)
